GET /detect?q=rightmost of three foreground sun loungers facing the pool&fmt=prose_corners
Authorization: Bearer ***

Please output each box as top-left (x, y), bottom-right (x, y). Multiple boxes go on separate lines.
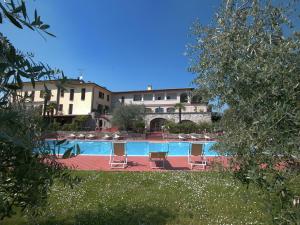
top-left (188, 143), bottom-right (207, 170)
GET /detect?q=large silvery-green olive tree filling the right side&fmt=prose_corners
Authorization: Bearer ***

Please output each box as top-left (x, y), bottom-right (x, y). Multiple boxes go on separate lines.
top-left (188, 0), bottom-right (300, 224)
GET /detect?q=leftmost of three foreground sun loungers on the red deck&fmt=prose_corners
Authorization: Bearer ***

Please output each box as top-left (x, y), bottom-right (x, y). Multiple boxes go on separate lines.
top-left (109, 142), bottom-right (127, 168)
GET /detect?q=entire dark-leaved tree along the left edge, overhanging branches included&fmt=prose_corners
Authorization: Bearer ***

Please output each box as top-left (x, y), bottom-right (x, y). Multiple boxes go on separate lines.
top-left (0, 0), bottom-right (72, 221)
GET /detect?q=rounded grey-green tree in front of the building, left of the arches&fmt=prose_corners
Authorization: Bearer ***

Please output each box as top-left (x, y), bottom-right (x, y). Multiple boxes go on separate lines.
top-left (112, 105), bottom-right (145, 131)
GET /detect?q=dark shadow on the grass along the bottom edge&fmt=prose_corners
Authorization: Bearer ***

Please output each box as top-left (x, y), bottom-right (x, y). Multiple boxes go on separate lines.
top-left (38, 205), bottom-right (174, 225)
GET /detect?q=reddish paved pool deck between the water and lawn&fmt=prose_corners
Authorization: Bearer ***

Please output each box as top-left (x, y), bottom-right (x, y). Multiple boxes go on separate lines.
top-left (59, 155), bottom-right (229, 171)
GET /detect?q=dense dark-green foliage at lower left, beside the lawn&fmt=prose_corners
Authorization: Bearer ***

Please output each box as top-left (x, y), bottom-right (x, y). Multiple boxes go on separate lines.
top-left (0, 107), bottom-right (77, 220)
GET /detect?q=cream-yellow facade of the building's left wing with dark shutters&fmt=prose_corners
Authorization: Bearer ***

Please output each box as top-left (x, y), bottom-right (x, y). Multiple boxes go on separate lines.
top-left (20, 80), bottom-right (111, 116)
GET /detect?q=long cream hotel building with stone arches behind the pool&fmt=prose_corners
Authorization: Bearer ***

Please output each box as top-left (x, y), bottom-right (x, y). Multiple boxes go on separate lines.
top-left (19, 79), bottom-right (211, 131)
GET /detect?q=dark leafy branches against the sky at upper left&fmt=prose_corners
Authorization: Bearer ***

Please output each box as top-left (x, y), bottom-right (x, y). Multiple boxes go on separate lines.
top-left (0, 0), bottom-right (60, 107)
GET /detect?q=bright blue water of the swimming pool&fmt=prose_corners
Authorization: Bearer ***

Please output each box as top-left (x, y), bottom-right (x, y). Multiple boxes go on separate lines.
top-left (48, 140), bottom-right (218, 156)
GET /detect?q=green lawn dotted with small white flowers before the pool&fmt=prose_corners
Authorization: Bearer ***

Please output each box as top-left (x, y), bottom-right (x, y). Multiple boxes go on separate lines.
top-left (2, 171), bottom-right (271, 225)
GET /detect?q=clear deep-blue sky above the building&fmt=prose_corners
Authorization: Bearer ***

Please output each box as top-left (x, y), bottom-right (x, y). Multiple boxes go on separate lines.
top-left (1, 0), bottom-right (220, 91)
